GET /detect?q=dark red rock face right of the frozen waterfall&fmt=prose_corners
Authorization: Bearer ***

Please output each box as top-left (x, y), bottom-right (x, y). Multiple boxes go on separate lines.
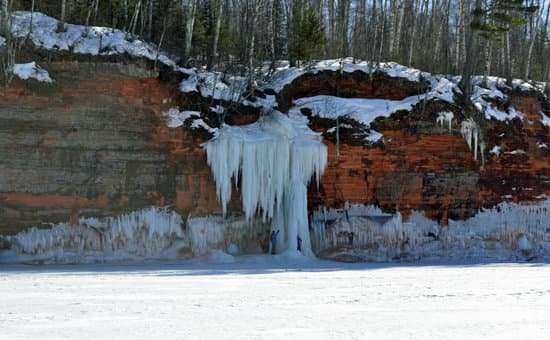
top-left (302, 77), bottom-right (550, 224)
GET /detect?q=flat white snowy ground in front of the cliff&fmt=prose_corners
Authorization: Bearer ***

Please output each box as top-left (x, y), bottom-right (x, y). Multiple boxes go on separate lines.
top-left (0, 256), bottom-right (550, 339)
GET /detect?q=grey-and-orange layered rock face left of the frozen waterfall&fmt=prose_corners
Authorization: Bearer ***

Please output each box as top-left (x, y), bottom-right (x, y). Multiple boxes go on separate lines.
top-left (0, 63), bottom-right (222, 233)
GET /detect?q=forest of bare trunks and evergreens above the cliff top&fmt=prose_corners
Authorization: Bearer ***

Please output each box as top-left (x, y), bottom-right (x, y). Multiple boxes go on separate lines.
top-left (2, 0), bottom-right (550, 81)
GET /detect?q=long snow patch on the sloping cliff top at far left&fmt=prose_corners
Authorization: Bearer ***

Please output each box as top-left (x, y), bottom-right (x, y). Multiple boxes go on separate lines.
top-left (11, 11), bottom-right (176, 67)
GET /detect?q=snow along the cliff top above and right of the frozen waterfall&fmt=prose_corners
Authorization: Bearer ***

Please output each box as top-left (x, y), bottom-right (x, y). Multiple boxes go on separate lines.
top-left (180, 58), bottom-right (550, 142)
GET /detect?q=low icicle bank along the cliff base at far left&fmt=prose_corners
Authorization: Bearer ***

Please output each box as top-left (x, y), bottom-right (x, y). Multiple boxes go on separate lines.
top-left (0, 208), bottom-right (187, 263)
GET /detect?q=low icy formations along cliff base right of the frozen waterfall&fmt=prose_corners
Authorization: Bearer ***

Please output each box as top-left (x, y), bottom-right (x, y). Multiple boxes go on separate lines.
top-left (311, 200), bottom-right (550, 261)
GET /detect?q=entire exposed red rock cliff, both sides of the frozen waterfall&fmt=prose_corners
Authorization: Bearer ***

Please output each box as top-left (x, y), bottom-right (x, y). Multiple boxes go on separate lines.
top-left (0, 63), bottom-right (550, 233)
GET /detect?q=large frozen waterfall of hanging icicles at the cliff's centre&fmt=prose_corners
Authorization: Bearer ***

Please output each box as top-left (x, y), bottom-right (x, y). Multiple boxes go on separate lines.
top-left (205, 111), bottom-right (327, 254)
